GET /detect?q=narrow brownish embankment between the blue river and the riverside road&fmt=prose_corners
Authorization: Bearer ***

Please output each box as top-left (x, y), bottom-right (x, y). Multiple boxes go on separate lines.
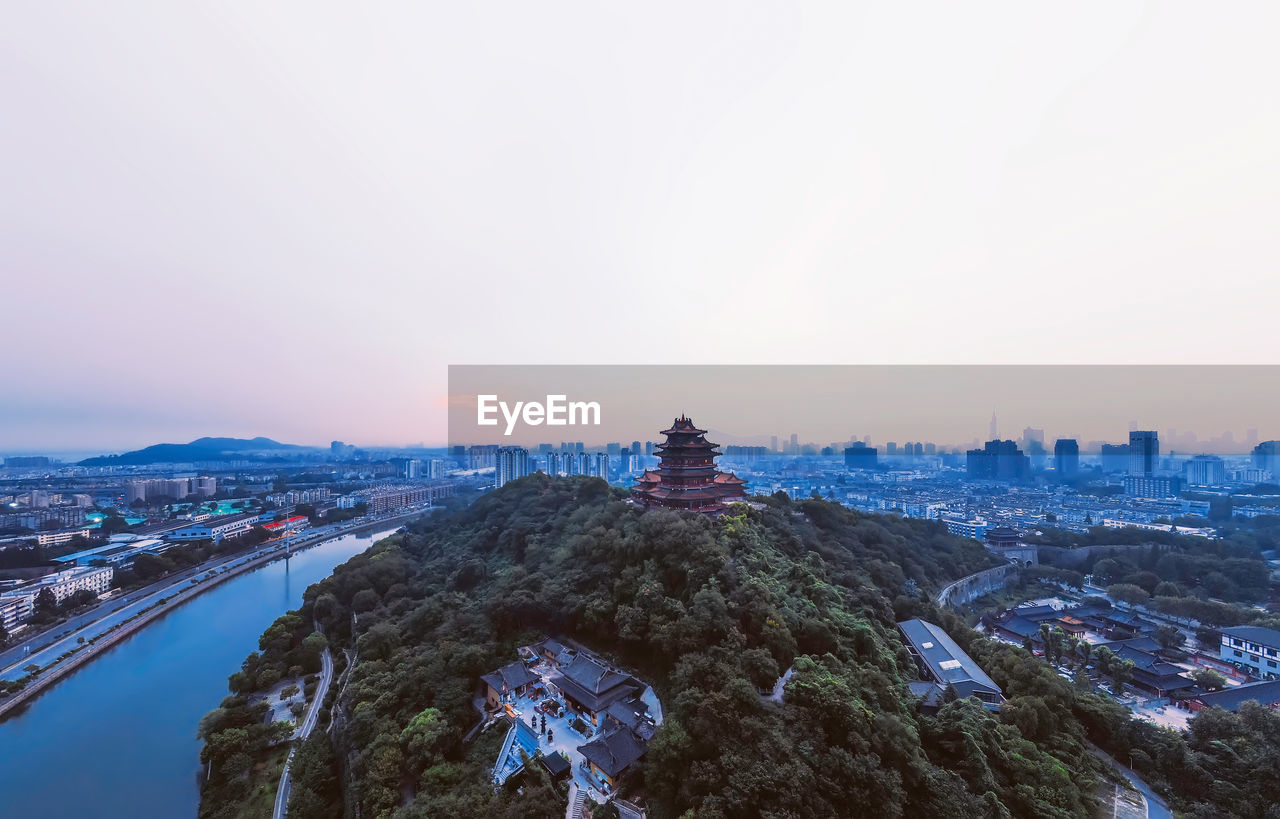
top-left (0, 509), bottom-right (431, 719)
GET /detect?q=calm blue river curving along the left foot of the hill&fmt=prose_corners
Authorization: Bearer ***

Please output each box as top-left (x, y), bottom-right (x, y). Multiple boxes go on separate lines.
top-left (0, 531), bottom-right (392, 819)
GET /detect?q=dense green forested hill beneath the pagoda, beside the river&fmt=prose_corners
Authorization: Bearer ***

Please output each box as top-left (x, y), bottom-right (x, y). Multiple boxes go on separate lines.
top-left (202, 475), bottom-right (1187, 819)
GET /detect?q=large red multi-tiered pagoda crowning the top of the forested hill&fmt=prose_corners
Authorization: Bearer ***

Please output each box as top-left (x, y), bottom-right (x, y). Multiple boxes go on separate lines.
top-left (631, 416), bottom-right (746, 514)
